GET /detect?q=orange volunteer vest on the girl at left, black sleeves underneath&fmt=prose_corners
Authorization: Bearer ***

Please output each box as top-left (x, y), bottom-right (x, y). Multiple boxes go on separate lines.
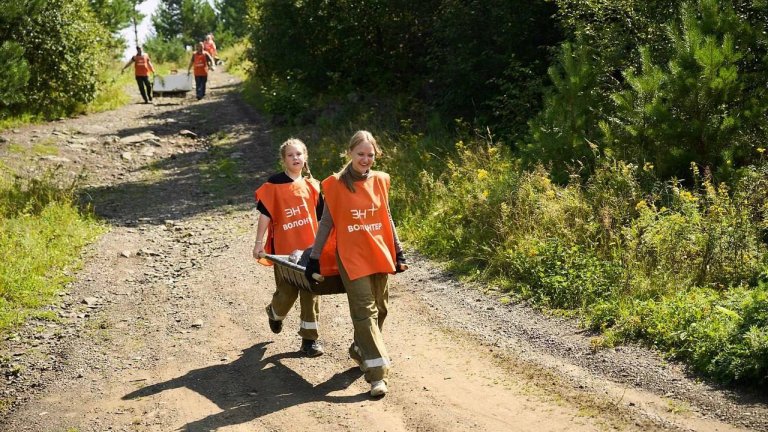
top-left (254, 179), bottom-right (339, 276)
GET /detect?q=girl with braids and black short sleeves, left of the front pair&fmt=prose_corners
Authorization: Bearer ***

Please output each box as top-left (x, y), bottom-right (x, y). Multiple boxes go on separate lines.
top-left (253, 138), bottom-right (332, 357)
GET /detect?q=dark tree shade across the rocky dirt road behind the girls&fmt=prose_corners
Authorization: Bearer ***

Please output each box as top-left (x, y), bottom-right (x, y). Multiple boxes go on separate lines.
top-left (81, 78), bottom-right (277, 225)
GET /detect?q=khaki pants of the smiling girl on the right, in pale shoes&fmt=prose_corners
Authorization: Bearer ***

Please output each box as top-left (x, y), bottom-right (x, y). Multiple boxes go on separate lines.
top-left (337, 258), bottom-right (390, 382)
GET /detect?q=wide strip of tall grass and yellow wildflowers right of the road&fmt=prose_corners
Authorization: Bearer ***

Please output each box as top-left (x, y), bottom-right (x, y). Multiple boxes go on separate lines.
top-left (274, 107), bottom-right (768, 384)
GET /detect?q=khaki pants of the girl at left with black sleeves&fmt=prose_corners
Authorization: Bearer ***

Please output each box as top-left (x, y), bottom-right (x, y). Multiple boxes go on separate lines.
top-left (271, 269), bottom-right (320, 340)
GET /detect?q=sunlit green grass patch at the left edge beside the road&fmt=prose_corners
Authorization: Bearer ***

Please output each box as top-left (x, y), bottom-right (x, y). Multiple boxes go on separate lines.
top-left (0, 169), bottom-right (105, 333)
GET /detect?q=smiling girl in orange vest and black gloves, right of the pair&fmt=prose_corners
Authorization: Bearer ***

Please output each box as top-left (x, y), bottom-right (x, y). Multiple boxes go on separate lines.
top-left (305, 131), bottom-right (407, 396)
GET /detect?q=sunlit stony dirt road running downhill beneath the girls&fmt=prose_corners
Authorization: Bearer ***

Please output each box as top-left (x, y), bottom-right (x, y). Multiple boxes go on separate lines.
top-left (0, 71), bottom-right (768, 432)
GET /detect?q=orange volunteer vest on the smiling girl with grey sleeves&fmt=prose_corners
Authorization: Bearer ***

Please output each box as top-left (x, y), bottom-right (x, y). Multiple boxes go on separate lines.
top-left (323, 171), bottom-right (395, 280)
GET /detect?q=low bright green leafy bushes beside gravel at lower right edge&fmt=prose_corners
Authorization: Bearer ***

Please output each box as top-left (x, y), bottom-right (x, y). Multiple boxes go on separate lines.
top-left (591, 284), bottom-right (768, 386)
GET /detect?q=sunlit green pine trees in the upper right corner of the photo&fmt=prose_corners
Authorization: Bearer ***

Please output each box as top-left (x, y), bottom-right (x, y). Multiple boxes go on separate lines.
top-left (528, 0), bottom-right (768, 179)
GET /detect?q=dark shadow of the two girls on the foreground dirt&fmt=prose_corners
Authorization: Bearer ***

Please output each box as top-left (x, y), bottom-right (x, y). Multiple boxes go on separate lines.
top-left (122, 342), bottom-right (369, 431)
